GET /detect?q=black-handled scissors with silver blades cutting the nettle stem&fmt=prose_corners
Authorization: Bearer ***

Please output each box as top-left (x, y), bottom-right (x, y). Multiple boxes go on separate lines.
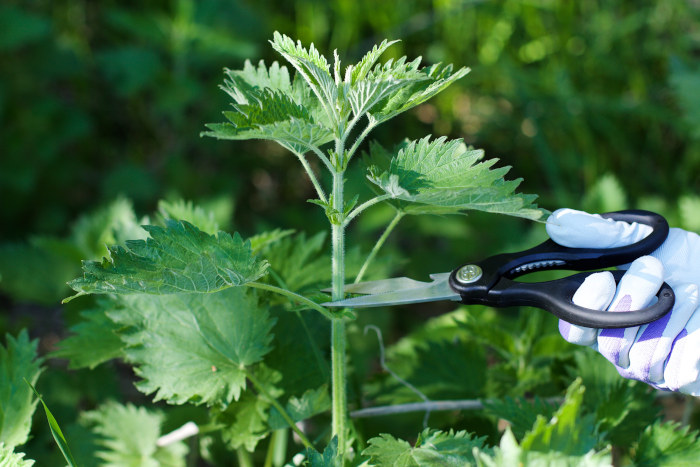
top-left (322, 210), bottom-right (675, 328)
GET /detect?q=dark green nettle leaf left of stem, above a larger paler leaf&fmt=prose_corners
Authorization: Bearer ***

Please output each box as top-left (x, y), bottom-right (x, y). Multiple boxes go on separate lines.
top-left (67, 220), bottom-right (268, 300)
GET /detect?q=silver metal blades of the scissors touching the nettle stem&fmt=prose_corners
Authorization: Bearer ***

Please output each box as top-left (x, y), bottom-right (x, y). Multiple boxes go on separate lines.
top-left (322, 272), bottom-right (461, 308)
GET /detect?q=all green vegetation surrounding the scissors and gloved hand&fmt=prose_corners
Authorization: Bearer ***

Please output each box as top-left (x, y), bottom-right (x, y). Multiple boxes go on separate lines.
top-left (0, 0), bottom-right (700, 466)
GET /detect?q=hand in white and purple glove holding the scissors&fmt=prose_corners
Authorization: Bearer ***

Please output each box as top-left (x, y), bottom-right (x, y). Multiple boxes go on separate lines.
top-left (547, 209), bottom-right (700, 396)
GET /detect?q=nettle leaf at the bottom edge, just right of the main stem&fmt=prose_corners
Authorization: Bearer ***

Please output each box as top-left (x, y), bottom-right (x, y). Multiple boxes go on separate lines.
top-left (362, 428), bottom-right (486, 467)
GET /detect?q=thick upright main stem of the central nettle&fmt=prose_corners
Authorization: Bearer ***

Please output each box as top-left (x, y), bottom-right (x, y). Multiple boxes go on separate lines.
top-left (331, 170), bottom-right (347, 458)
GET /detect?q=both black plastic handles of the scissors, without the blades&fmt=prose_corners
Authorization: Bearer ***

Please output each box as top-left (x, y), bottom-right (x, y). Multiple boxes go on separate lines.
top-left (449, 210), bottom-right (675, 328)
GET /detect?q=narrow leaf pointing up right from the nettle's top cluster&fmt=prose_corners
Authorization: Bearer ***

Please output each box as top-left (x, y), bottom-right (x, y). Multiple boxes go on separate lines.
top-left (368, 62), bottom-right (470, 124)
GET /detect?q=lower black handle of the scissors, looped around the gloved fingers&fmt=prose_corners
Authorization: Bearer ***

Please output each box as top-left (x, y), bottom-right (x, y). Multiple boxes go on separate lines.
top-left (489, 271), bottom-right (675, 329)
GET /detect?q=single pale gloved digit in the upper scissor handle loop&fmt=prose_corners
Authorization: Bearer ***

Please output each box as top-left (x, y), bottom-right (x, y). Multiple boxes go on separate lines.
top-left (546, 208), bottom-right (653, 248)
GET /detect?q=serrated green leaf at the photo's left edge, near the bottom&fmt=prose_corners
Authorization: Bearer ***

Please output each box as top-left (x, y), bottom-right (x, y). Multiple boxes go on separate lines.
top-left (0, 330), bottom-right (42, 449)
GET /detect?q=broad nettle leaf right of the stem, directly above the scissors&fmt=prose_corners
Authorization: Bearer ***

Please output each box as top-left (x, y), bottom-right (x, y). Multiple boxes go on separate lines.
top-left (368, 137), bottom-right (542, 219)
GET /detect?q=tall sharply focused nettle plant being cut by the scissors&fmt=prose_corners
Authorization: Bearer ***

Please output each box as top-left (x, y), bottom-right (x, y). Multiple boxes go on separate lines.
top-left (61, 33), bottom-right (541, 462)
